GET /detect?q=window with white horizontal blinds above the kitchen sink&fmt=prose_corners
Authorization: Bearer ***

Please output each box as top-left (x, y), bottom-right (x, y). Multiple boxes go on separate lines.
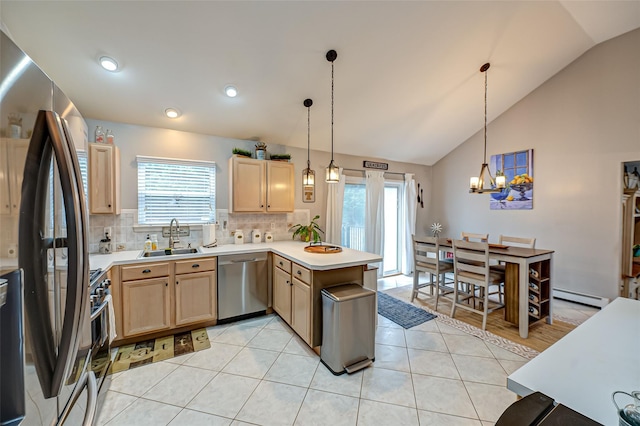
top-left (136, 156), bottom-right (216, 225)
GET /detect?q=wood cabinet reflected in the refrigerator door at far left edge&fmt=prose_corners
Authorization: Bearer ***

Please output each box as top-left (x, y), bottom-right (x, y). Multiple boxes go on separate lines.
top-left (0, 138), bottom-right (29, 215)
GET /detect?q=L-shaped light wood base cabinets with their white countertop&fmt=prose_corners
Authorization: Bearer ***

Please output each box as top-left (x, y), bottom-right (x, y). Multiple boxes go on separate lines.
top-left (90, 241), bottom-right (382, 347)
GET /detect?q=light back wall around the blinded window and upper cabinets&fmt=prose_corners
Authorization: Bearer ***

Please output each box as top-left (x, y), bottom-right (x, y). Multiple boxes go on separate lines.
top-left (81, 119), bottom-right (430, 240)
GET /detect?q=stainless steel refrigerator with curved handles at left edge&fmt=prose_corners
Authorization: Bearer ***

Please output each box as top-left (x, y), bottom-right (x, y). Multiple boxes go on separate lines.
top-left (0, 28), bottom-right (97, 426)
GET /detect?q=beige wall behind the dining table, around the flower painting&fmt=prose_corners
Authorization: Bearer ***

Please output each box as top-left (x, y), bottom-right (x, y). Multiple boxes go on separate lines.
top-left (430, 30), bottom-right (640, 298)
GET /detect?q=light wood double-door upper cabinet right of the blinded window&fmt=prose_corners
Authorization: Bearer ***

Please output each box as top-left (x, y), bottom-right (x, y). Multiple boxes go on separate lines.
top-left (229, 157), bottom-right (295, 213)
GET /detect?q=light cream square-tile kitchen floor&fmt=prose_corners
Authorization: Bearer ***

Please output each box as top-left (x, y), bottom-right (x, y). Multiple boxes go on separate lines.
top-left (97, 279), bottom-right (590, 426)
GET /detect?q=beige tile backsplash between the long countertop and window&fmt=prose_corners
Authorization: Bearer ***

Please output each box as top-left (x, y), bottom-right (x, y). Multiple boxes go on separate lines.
top-left (88, 209), bottom-right (311, 253)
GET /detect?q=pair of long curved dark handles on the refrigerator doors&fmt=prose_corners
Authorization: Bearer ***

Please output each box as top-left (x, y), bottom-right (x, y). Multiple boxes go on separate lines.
top-left (19, 110), bottom-right (89, 398)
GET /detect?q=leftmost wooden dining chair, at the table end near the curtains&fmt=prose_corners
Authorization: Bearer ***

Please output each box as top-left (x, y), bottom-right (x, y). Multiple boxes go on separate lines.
top-left (411, 235), bottom-right (453, 310)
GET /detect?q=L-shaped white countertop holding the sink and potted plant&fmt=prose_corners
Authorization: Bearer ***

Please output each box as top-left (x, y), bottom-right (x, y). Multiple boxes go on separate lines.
top-left (89, 241), bottom-right (382, 271)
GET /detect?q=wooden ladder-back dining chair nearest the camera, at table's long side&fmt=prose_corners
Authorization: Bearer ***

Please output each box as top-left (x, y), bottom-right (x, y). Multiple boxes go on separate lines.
top-left (451, 240), bottom-right (504, 330)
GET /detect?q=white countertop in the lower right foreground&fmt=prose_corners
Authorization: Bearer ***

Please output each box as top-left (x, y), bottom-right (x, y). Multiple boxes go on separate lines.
top-left (507, 297), bottom-right (640, 425)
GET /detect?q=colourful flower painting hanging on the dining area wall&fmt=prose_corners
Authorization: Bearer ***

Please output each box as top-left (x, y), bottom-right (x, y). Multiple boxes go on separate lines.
top-left (489, 149), bottom-right (533, 210)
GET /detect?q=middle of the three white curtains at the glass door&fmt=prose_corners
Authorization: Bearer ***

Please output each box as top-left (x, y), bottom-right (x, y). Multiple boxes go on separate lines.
top-left (364, 170), bottom-right (384, 277)
